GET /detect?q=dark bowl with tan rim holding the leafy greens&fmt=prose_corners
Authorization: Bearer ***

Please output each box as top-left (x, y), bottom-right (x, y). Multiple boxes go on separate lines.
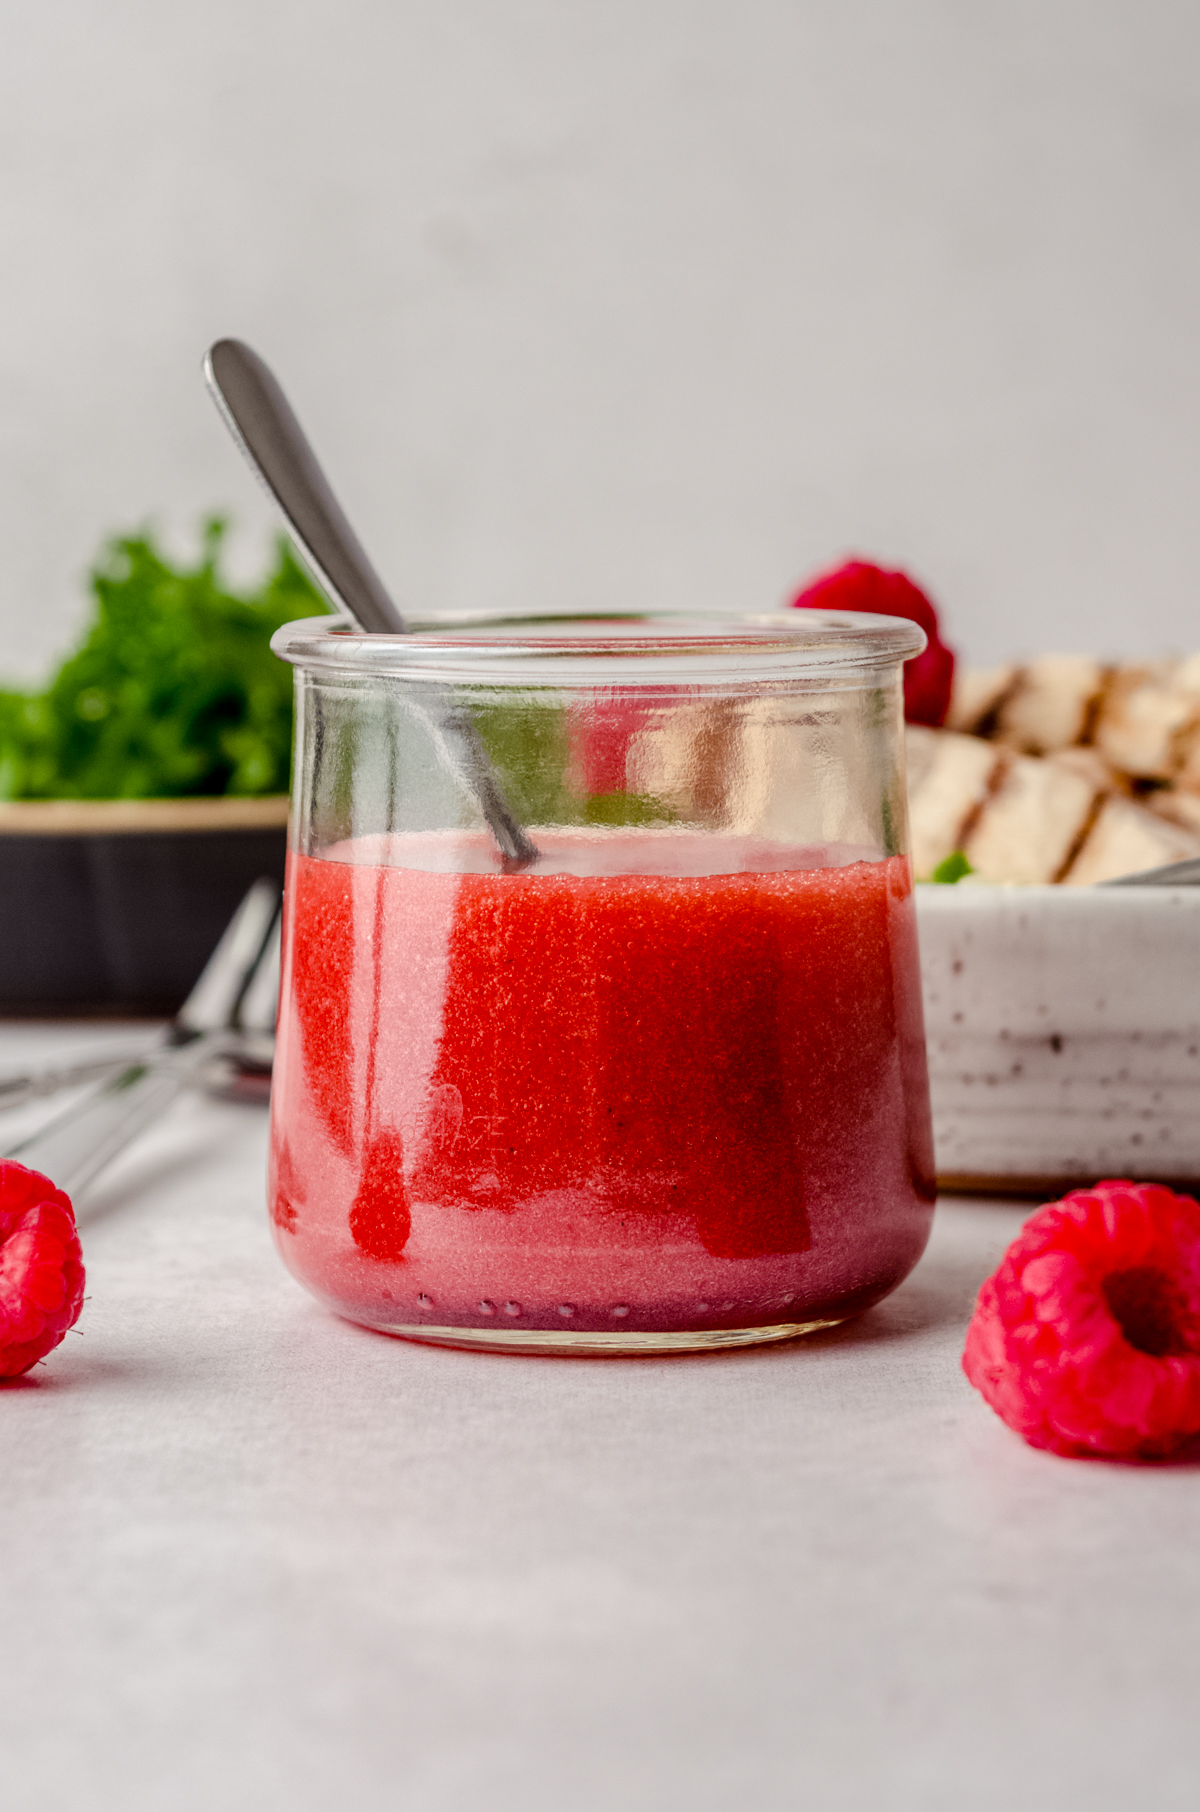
top-left (0, 799), bottom-right (288, 1015)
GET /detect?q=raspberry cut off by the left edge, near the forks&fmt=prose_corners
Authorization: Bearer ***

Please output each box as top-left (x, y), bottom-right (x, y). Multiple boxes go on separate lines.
top-left (0, 1160), bottom-right (83, 1377)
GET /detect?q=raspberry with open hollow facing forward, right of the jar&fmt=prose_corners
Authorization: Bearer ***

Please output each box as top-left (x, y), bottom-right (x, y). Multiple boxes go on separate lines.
top-left (963, 1181), bottom-right (1200, 1459)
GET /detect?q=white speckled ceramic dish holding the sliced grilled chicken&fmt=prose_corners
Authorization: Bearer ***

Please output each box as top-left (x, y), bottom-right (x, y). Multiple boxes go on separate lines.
top-left (917, 886), bottom-right (1200, 1194)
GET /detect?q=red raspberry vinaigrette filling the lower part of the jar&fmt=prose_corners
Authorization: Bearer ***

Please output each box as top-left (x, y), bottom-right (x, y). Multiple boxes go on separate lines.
top-left (270, 837), bottom-right (934, 1350)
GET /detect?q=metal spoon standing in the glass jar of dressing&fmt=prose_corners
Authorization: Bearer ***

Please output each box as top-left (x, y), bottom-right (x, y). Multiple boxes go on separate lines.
top-left (205, 339), bottom-right (538, 868)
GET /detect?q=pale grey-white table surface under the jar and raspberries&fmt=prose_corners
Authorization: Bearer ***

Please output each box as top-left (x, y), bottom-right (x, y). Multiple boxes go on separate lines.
top-left (0, 1026), bottom-right (1200, 1812)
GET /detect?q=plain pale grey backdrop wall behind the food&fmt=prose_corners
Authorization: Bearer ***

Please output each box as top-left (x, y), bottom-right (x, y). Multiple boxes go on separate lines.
top-left (0, 0), bottom-right (1200, 676)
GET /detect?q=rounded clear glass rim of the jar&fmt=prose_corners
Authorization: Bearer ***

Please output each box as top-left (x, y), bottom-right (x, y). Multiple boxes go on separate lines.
top-left (270, 609), bottom-right (926, 685)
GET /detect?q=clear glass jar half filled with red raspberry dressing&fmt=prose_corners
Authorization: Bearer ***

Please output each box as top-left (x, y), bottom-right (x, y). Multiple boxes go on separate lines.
top-left (270, 611), bottom-right (934, 1354)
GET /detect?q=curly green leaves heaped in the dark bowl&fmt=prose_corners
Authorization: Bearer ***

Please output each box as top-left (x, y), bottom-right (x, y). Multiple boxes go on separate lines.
top-left (0, 516), bottom-right (328, 799)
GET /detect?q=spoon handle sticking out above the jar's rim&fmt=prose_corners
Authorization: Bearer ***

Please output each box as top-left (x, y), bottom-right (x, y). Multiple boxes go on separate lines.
top-left (205, 339), bottom-right (404, 636)
